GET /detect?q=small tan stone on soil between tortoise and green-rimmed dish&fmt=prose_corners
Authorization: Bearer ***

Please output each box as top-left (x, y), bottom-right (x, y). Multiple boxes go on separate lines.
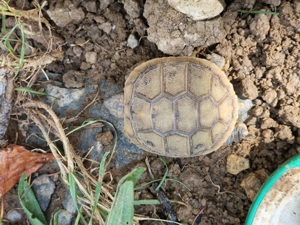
top-left (226, 154), bottom-right (250, 175)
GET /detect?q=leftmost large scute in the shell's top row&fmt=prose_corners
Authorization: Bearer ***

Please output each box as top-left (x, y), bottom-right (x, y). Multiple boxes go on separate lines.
top-left (135, 67), bottom-right (162, 99)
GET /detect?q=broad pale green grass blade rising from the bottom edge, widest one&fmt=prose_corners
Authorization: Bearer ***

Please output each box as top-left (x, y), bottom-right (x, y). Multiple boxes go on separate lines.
top-left (105, 180), bottom-right (134, 225)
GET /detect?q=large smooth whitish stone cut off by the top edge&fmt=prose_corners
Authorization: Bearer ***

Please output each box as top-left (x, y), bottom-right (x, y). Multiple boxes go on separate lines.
top-left (168, 0), bottom-right (225, 20)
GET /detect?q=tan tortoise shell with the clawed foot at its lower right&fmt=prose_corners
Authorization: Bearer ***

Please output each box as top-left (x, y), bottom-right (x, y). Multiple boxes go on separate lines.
top-left (124, 56), bottom-right (248, 157)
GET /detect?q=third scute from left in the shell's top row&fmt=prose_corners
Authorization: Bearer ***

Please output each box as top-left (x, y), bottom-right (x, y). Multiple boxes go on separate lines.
top-left (188, 65), bottom-right (212, 97)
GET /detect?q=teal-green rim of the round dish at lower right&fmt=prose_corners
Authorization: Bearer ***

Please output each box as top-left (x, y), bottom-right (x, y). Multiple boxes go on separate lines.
top-left (245, 154), bottom-right (300, 225)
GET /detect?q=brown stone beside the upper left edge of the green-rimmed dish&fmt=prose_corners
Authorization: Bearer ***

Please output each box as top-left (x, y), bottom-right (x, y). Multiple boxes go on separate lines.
top-left (241, 169), bottom-right (269, 201)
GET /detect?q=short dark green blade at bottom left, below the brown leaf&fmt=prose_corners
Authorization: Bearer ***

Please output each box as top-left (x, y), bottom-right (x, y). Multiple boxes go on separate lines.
top-left (18, 174), bottom-right (47, 225)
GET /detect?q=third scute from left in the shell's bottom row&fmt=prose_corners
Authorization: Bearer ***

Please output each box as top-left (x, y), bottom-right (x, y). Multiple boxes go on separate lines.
top-left (191, 130), bottom-right (213, 155)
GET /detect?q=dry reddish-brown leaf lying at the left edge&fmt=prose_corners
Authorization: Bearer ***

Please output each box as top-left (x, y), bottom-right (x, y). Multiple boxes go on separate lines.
top-left (0, 145), bottom-right (54, 198)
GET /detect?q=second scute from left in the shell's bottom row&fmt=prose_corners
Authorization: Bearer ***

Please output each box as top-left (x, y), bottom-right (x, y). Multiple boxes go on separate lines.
top-left (166, 134), bottom-right (190, 157)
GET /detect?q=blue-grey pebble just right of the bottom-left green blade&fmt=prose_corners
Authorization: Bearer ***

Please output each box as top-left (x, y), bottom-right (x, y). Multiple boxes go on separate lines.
top-left (32, 175), bottom-right (55, 211)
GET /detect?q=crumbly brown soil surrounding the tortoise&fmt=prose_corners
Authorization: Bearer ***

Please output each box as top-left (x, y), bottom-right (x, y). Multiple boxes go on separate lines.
top-left (2, 0), bottom-right (300, 225)
